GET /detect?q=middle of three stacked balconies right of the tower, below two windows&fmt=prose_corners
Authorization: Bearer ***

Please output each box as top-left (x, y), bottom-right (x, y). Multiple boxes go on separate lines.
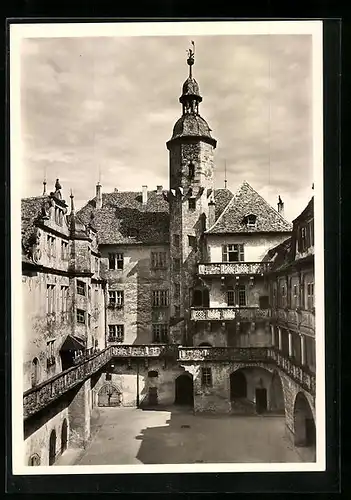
top-left (190, 307), bottom-right (271, 321)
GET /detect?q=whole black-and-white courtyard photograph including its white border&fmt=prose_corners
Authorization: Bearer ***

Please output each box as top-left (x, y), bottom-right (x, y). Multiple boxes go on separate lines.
top-left (10, 21), bottom-right (326, 475)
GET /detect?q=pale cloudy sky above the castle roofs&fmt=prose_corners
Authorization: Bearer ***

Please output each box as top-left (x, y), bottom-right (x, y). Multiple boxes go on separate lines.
top-left (20, 35), bottom-right (313, 220)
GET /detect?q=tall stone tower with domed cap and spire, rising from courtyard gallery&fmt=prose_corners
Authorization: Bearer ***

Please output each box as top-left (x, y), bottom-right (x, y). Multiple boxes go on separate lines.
top-left (167, 42), bottom-right (217, 344)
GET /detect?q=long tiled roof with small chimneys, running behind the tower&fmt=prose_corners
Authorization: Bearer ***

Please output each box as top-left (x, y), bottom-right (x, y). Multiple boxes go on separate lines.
top-left (77, 189), bottom-right (233, 245)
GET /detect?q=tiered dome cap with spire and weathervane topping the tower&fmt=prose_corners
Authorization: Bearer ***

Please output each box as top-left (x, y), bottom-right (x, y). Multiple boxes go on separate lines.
top-left (167, 42), bottom-right (217, 148)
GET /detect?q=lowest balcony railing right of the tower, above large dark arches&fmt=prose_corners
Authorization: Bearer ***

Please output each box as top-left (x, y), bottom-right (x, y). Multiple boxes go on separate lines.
top-left (178, 347), bottom-right (268, 362)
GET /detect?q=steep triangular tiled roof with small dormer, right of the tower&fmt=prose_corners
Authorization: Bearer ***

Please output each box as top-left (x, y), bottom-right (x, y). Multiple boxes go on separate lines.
top-left (207, 182), bottom-right (292, 234)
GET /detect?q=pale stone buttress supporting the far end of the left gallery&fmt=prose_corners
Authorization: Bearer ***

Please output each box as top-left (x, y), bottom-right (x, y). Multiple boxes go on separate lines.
top-left (68, 379), bottom-right (90, 448)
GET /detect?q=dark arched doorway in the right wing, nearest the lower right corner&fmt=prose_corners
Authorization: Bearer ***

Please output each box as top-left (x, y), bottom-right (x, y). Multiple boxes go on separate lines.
top-left (294, 392), bottom-right (316, 449)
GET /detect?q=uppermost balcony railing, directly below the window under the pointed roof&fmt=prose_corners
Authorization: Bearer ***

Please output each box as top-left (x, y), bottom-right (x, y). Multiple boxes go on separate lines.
top-left (198, 262), bottom-right (271, 276)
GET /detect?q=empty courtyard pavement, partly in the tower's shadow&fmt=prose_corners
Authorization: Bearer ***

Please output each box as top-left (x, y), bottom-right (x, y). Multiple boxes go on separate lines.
top-left (64, 407), bottom-right (302, 465)
